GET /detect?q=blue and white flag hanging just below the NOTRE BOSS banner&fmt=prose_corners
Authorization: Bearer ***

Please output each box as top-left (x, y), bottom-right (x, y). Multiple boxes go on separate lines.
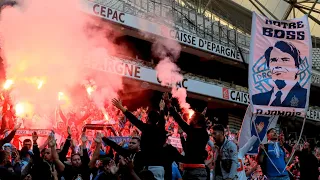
top-left (238, 107), bottom-right (279, 154)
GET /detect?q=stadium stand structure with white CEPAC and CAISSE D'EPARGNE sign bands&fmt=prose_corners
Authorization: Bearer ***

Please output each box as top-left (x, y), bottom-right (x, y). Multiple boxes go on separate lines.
top-left (82, 0), bottom-right (320, 138)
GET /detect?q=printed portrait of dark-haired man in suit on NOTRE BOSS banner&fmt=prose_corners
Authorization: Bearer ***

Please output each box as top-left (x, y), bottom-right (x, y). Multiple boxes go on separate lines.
top-left (252, 41), bottom-right (307, 108)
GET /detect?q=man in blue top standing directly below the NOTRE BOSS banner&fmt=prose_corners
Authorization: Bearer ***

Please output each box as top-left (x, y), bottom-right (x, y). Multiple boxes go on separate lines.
top-left (257, 128), bottom-right (290, 180)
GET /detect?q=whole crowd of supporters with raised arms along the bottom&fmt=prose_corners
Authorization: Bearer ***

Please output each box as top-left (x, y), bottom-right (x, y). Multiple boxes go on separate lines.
top-left (0, 94), bottom-right (320, 180)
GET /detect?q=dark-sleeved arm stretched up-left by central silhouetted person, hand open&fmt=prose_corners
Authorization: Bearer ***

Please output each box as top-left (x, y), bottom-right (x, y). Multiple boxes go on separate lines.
top-left (112, 99), bottom-right (147, 131)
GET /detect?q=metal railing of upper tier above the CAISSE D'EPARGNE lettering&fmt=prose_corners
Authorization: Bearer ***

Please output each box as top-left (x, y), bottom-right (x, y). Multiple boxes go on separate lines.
top-left (93, 0), bottom-right (320, 65)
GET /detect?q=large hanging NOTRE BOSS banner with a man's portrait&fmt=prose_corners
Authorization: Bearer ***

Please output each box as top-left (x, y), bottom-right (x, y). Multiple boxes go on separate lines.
top-left (249, 13), bottom-right (312, 116)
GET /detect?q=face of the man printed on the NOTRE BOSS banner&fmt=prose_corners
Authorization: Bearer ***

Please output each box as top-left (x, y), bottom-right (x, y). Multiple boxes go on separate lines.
top-left (269, 48), bottom-right (298, 80)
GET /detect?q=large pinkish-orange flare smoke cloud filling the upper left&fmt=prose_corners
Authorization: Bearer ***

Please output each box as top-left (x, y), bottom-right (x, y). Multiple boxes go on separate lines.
top-left (0, 0), bottom-right (122, 128)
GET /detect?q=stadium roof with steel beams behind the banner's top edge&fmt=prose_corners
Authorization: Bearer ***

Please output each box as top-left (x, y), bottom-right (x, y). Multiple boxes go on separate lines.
top-left (182, 0), bottom-right (320, 37)
